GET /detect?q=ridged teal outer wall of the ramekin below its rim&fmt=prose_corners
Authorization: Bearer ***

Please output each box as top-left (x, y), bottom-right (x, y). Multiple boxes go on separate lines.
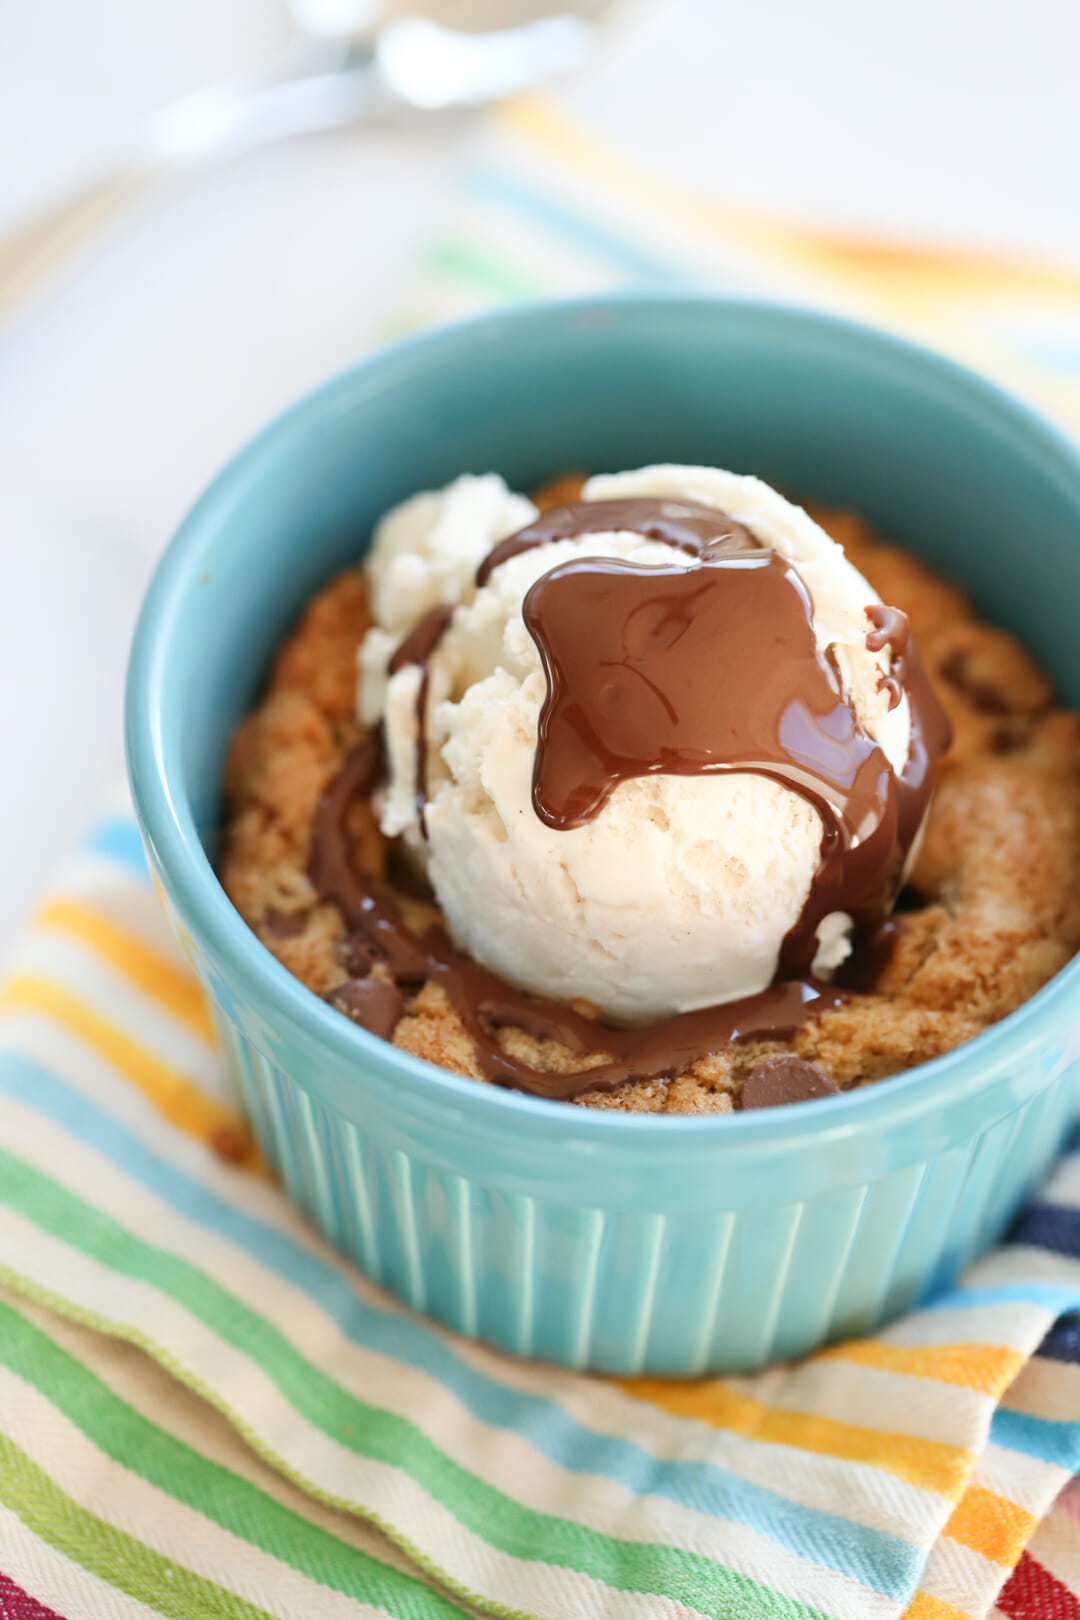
top-left (173, 894), bottom-right (1080, 1377)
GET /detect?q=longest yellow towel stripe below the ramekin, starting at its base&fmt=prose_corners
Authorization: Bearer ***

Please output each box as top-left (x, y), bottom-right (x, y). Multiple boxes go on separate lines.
top-left (622, 1379), bottom-right (975, 1502)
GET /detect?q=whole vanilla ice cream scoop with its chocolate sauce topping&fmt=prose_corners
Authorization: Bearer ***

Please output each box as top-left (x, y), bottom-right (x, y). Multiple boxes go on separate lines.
top-left (359, 467), bottom-right (941, 1022)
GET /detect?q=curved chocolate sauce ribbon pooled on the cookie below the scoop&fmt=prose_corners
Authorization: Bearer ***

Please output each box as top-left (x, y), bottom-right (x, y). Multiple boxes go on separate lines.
top-left (309, 735), bottom-right (847, 1102)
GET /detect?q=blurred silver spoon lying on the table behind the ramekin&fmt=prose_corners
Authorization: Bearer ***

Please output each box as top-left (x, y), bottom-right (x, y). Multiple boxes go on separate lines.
top-left (0, 0), bottom-right (604, 332)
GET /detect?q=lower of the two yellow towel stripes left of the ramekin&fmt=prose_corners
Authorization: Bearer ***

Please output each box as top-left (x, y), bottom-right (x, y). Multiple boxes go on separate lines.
top-left (0, 974), bottom-right (262, 1170)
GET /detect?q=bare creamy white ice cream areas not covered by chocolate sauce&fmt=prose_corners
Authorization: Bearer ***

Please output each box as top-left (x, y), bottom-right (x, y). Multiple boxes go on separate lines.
top-left (359, 467), bottom-right (912, 1022)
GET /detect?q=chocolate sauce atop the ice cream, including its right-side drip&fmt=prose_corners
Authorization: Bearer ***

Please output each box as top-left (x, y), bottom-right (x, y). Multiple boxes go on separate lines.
top-left (524, 501), bottom-right (949, 978)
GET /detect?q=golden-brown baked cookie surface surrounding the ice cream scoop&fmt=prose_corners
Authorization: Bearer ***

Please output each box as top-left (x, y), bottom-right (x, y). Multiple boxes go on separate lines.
top-left (220, 495), bottom-right (1080, 1115)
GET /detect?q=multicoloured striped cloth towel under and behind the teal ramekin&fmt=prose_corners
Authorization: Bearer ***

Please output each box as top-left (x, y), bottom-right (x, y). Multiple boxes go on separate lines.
top-left (0, 91), bottom-right (1080, 1620)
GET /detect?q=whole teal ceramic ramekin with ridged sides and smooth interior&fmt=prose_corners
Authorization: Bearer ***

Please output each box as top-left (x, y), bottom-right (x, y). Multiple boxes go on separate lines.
top-left (126, 296), bottom-right (1080, 1375)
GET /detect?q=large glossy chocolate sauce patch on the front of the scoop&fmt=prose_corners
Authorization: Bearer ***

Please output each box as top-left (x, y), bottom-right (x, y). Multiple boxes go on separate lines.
top-left (523, 551), bottom-right (889, 844)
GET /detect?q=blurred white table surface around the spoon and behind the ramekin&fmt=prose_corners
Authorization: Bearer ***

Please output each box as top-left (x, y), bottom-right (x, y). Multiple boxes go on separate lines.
top-left (0, 0), bottom-right (1080, 953)
